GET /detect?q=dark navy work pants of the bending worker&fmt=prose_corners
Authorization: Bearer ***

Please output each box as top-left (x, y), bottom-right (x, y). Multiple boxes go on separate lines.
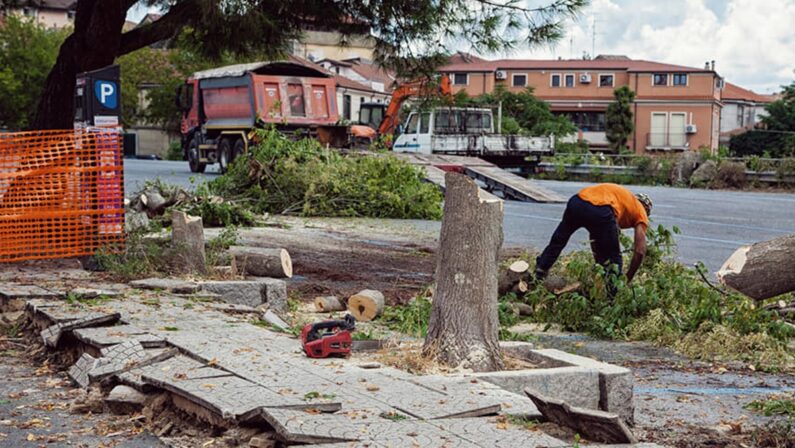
top-left (536, 195), bottom-right (622, 296)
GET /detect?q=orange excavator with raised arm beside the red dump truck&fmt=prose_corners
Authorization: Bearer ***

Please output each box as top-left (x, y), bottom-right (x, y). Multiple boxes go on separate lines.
top-left (351, 75), bottom-right (453, 142)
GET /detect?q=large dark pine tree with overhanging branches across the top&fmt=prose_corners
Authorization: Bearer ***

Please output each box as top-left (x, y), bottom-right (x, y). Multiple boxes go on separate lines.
top-left (26, 0), bottom-right (588, 128)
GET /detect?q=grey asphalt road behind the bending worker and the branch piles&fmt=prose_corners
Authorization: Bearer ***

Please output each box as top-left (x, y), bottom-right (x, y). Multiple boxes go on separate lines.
top-left (124, 159), bottom-right (795, 271)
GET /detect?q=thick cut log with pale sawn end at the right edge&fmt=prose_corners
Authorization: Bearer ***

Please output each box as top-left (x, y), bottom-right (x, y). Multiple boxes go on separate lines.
top-left (718, 235), bottom-right (795, 300)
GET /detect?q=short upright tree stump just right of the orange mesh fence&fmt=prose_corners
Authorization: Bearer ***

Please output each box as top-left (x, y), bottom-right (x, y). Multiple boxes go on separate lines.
top-left (171, 210), bottom-right (207, 274)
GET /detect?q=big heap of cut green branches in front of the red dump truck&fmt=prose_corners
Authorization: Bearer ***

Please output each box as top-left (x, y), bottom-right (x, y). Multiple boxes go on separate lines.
top-left (202, 129), bottom-right (442, 219)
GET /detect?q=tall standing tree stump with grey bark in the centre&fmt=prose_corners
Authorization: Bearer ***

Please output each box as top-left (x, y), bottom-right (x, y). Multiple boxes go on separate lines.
top-left (423, 173), bottom-right (503, 372)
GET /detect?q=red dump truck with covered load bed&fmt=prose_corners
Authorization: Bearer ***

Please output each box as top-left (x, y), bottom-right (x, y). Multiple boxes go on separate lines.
top-left (177, 62), bottom-right (348, 173)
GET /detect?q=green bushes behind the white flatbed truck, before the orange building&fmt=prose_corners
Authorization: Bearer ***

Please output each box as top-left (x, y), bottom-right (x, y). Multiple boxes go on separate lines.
top-left (453, 84), bottom-right (577, 137)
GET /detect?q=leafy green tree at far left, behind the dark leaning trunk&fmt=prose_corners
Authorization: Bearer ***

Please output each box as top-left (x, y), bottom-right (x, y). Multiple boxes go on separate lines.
top-left (0, 14), bottom-right (70, 130)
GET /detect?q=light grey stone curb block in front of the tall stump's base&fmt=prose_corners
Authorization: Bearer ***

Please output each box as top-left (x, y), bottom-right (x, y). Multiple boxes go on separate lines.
top-left (472, 367), bottom-right (600, 409)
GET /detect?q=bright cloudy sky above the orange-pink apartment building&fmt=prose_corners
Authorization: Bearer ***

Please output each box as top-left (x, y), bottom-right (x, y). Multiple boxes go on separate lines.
top-left (128, 0), bottom-right (795, 93)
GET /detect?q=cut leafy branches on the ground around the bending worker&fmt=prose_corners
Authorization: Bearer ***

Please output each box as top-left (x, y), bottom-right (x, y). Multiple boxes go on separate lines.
top-left (522, 226), bottom-right (793, 369)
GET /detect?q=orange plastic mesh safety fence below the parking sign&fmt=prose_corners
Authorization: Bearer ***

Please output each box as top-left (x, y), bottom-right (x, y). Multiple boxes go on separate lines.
top-left (0, 129), bottom-right (124, 262)
